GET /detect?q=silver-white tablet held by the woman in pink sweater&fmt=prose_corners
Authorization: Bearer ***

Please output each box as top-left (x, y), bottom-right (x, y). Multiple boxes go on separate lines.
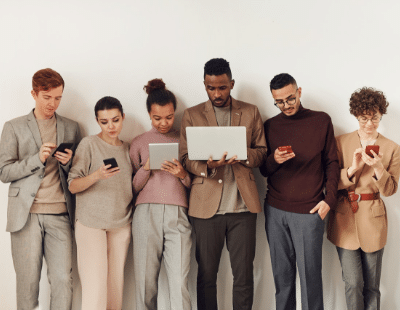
top-left (149, 143), bottom-right (179, 170)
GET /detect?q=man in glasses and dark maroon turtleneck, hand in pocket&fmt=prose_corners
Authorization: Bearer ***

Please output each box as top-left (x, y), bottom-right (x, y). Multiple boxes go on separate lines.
top-left (260, 73), bottom-right (339, 310)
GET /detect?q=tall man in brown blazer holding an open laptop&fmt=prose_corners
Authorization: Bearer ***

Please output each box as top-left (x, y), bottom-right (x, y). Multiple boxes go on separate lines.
top-left (180, 58), bottom-right (267, 310)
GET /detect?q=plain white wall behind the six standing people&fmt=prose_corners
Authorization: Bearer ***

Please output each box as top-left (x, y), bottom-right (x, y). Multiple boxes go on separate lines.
top-left (0, 0), bottom-right (400, 310)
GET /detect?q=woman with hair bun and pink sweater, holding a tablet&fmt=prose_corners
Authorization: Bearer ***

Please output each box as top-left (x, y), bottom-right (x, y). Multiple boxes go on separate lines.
top-left (130, 79), bottom-right (192, 310)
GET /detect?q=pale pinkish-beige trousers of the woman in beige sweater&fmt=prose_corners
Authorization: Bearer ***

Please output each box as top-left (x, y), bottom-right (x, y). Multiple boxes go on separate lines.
top-left (75, 221), bottom-right (131, 310)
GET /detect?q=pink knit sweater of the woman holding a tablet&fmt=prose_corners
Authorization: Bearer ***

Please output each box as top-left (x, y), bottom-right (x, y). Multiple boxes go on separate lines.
top-left (129, 127), bottom-right (191, 208)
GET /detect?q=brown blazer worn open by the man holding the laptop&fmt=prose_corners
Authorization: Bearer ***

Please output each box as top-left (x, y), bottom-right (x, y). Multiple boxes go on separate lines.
top-left (179, 98), bottom-right (267, 219)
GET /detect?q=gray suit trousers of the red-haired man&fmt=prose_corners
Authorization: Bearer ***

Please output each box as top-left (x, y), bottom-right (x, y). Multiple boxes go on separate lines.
top-left (11, 213), bottom-right (72, 310)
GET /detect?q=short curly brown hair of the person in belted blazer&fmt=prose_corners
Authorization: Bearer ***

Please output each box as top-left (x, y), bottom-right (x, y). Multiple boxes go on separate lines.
top-left (350, 87), bottom-right (389, 117)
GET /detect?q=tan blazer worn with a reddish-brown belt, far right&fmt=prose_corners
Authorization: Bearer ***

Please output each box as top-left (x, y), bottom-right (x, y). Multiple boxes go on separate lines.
top-left (328, 131), bottom-right (400, 253)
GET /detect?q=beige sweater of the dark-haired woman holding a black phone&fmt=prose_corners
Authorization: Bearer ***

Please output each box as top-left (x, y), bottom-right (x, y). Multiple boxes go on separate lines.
top-left (68, 136), bottom-right (133, 229)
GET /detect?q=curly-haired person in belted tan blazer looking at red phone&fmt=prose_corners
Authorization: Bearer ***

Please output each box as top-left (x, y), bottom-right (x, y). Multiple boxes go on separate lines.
top-left (328, 87), bottom-right (400, 310)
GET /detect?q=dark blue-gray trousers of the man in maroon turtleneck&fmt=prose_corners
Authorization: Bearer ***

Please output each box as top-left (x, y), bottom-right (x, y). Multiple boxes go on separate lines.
top-left (264, 203), bottom-right (324, 310)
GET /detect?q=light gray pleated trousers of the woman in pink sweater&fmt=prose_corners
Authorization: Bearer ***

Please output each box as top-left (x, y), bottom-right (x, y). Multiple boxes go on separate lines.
top-left (132, 204), bottom-right (192, 310)
